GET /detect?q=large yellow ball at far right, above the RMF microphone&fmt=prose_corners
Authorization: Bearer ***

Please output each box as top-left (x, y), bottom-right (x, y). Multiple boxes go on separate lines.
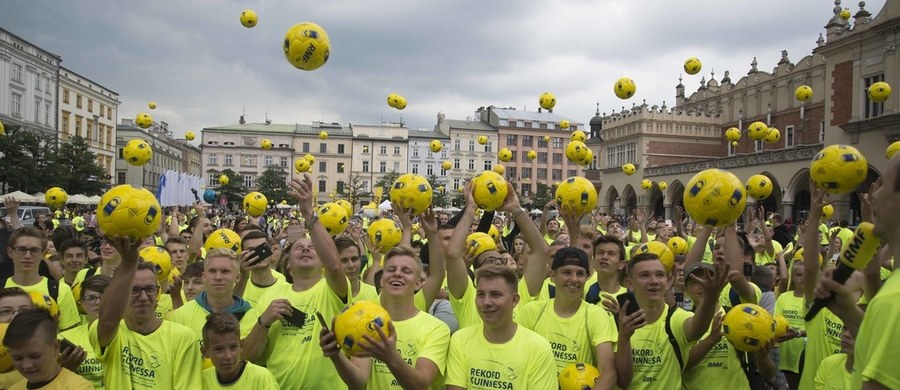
top-left (809, 144), bottom-right (869, 195)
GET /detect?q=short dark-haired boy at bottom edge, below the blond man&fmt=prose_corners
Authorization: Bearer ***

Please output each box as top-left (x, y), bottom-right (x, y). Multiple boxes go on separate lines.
top-left (200, 312), bottom-right (278, 390)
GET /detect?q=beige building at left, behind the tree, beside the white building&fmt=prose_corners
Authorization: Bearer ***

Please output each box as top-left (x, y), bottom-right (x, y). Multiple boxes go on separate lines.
top-left (57, 67), bottom-right (121, 179)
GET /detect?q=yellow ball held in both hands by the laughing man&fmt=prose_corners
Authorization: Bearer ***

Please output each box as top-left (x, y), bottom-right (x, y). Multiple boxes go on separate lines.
top-left (334, 301), bottom-right (391, 356)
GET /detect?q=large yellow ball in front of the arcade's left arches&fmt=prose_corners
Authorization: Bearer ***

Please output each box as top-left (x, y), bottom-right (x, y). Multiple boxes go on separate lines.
top-left (683, 169), bottom-right (747, 227)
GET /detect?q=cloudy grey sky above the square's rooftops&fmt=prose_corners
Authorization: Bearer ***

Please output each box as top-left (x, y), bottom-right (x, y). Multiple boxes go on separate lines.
top-left (0, 0), bottom-right (885, 142)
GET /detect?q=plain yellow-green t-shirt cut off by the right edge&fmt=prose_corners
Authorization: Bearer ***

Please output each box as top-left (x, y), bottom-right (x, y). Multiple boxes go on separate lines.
top-left (853, 272), bottom-right (900, 389)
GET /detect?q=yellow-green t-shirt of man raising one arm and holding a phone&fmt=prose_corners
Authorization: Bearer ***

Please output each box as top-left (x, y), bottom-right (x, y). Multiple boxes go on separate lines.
top-left (255, 278), bottom-right (346, 389)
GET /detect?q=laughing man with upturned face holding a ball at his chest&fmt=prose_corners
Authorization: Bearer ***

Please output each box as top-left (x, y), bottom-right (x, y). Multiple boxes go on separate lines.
top-left (319, 246), bottom-right (450, 389)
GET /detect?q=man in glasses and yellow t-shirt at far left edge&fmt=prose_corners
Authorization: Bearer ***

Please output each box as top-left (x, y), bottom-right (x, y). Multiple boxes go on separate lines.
top-left (0, 227), bottom-right (81, 330)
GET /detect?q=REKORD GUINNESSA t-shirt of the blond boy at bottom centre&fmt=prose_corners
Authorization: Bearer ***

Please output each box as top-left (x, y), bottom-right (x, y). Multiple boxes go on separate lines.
top-left (445, 323), bottom-right (558, 390)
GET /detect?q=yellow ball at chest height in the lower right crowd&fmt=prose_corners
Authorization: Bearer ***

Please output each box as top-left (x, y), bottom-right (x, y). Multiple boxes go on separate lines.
top-left (722, 303), bottom-right (775, 352)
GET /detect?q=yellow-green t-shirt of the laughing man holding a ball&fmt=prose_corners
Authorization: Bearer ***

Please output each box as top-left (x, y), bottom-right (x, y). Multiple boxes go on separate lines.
top-left (366, 311), bottom-right (450, 390)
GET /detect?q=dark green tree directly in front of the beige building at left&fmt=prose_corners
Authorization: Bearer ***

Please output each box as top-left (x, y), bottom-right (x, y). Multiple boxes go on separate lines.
top-left (56, 135), bottom-right (108, 196)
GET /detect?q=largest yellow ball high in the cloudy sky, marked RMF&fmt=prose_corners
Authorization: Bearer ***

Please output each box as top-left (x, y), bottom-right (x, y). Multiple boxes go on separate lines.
top-left (283, 22), bottom-right (331, 70)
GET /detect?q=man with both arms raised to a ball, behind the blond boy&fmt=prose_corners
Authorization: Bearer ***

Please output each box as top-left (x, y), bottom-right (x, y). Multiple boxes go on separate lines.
top-left (444, 182), bottom-right (549, 329)
